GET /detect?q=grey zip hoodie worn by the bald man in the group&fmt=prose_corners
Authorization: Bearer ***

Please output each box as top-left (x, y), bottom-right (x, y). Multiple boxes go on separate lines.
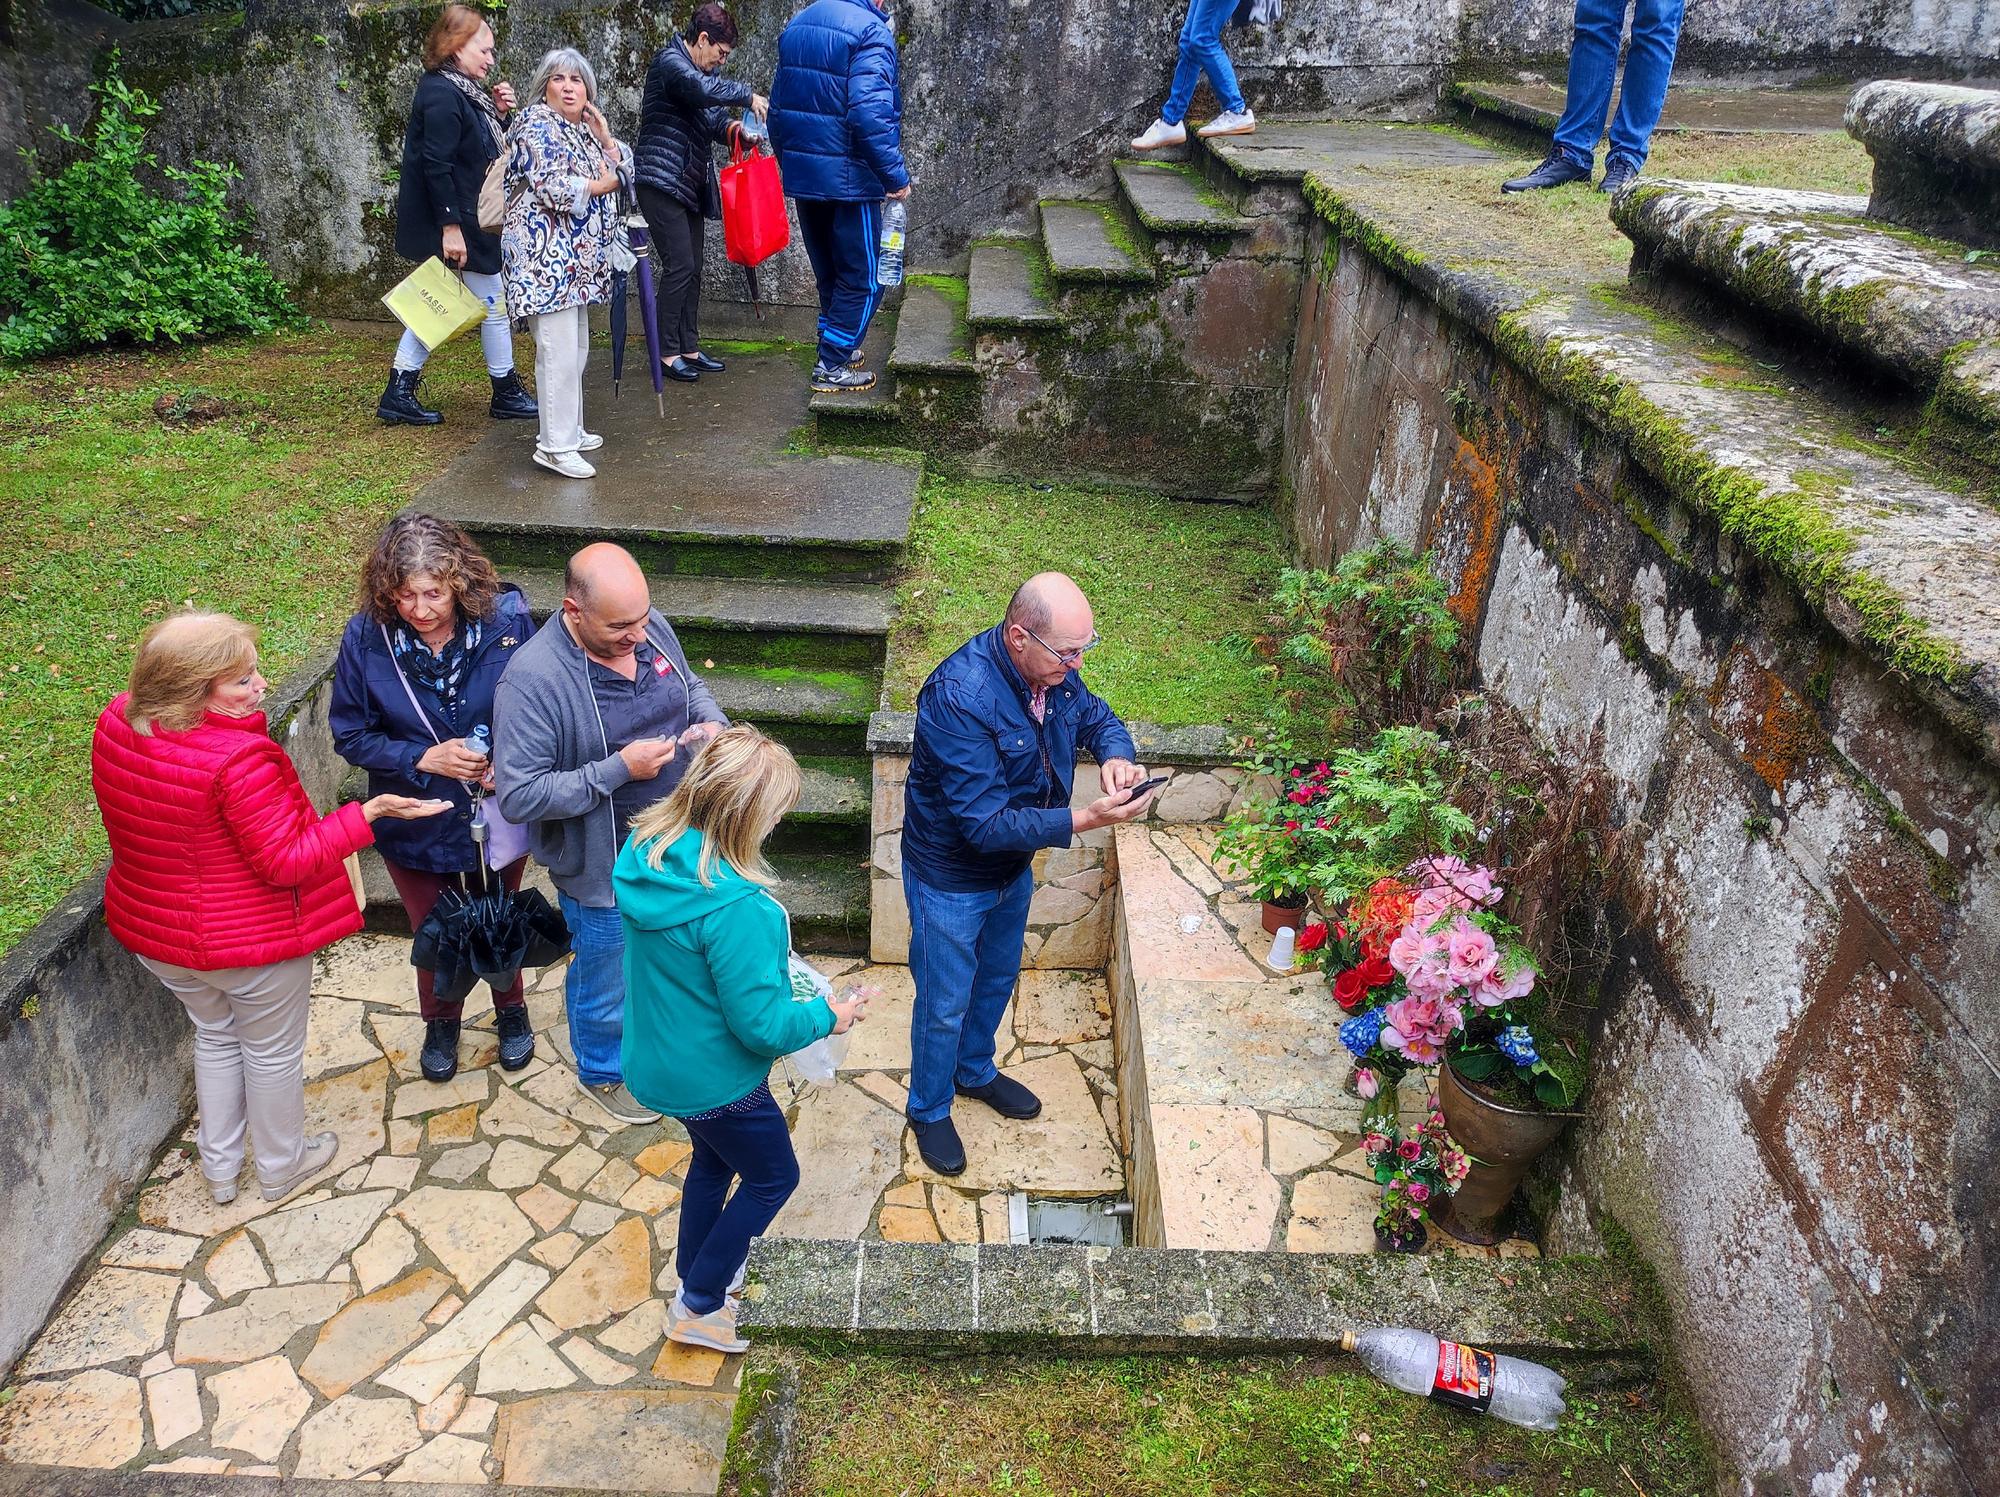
top-left (494, 608), bottom-right (728, 909)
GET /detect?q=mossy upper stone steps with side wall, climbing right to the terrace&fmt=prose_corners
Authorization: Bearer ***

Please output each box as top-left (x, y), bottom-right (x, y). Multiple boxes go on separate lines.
top-left (812, 152), bottom-right (1302, 498)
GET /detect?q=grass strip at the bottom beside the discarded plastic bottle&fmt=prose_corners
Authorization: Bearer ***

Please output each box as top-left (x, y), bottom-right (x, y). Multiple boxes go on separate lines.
top-left (786, 1353), bottom-right (1714, 1497)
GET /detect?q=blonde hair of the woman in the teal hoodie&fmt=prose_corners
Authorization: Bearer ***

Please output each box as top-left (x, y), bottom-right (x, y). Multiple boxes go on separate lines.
top-left (632, 722), bottom-right (800, 889)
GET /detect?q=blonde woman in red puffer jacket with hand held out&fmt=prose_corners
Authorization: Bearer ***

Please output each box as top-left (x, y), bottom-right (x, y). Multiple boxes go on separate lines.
top-left (90, 612), bottom-right (450, 1205)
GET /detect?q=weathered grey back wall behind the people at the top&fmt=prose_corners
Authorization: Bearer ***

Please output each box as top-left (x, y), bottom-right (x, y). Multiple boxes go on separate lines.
top-left (0, 0), bottom-right (2000, 316)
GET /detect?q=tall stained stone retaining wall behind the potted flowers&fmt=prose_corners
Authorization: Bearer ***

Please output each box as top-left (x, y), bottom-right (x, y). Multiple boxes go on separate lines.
top-left (1288, 216), bottom-right (2000, 1497)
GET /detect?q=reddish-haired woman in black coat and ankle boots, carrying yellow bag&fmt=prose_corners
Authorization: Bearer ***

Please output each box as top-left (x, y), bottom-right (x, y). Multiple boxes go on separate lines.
top-left (376, 6), bottom-right (536, 426)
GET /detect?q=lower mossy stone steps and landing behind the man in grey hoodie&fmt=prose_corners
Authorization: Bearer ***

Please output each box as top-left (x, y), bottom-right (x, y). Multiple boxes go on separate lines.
top-left (376, 352), bottom-right (918, 951)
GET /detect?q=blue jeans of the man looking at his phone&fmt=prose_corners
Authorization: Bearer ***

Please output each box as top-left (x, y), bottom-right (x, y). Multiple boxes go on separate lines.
top-left (902, 865), bottom-right (1034, 1123)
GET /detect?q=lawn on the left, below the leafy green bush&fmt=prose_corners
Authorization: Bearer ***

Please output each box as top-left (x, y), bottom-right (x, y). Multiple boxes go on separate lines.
top-left (0, 326), bottom-right (488, 949)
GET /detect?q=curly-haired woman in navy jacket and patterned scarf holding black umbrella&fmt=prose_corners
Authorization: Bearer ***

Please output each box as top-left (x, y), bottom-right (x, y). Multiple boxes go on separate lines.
top-left (328, 514), bottom-right (534, 1081)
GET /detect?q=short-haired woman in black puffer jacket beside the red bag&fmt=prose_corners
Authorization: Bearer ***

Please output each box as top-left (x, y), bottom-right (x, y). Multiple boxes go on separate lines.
top-left (632, 4), bottom-right (770, 382)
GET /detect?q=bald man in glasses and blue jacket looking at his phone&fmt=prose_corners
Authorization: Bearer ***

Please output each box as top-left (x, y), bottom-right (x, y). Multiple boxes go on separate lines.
top-left (902, 572), bottom-right (1156, 1175)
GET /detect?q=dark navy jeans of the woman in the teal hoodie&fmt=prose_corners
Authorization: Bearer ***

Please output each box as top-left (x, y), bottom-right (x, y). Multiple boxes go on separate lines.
top-left (674, 1089), bottom-right (798, 1315)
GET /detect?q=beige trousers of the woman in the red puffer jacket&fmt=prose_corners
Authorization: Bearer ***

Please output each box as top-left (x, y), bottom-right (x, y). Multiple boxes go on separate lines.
top-left (140, 957), bottom-right (312, 1185)
